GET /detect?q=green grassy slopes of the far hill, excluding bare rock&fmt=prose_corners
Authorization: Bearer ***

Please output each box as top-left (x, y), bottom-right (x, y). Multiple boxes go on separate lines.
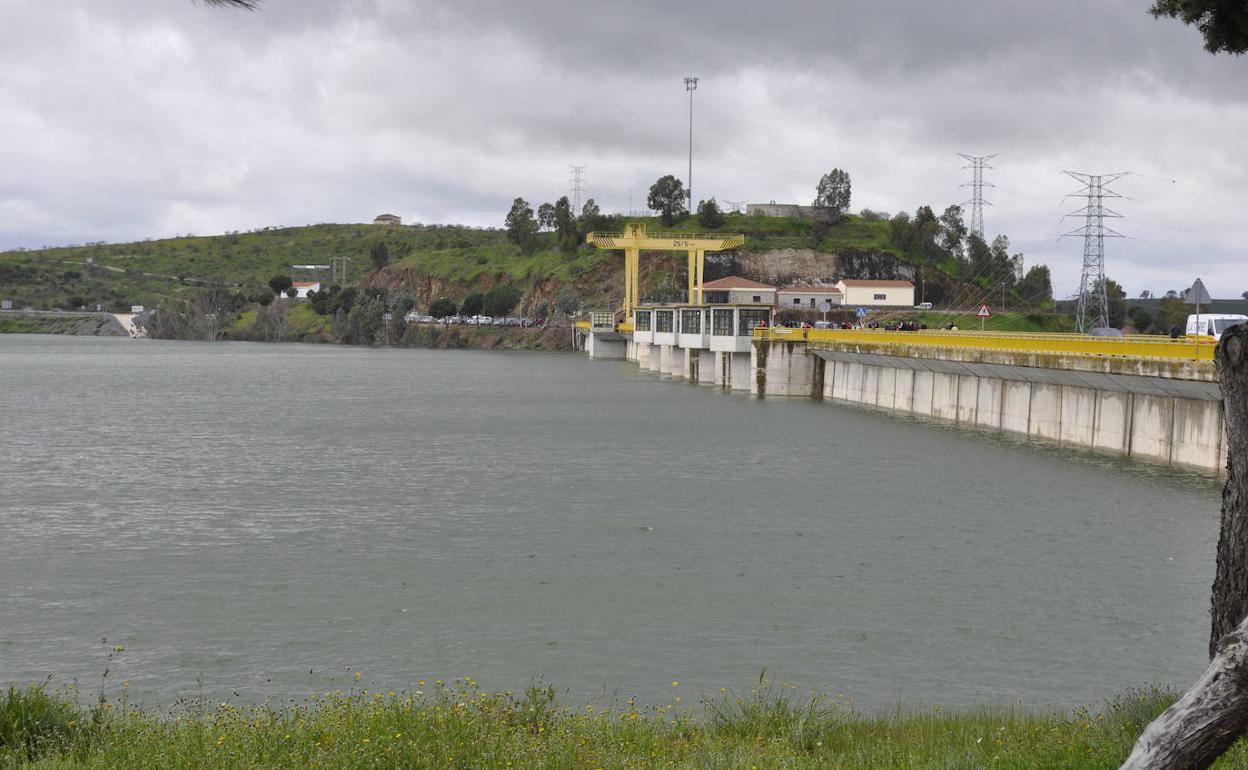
top-left (0, 215), bottom-right (905, 309)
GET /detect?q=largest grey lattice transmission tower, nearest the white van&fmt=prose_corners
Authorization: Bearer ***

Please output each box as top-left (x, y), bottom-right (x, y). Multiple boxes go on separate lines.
top-left (1062, 171), bottom-right (1127, 332)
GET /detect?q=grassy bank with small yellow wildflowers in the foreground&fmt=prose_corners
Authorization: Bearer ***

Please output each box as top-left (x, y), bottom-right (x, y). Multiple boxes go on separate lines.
top-left (0, 680), bottom-right (1248, 770)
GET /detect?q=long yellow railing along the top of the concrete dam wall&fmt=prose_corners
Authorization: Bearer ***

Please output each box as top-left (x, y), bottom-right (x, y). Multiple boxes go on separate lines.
top-left (754, 327), bottom-right (1214, 361)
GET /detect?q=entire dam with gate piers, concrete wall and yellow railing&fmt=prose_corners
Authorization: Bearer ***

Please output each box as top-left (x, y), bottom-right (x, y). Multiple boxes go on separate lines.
top-left (578, 305), bottom-right (1227, 473)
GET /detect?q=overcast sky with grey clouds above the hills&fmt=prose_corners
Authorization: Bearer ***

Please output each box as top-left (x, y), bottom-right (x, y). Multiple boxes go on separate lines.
top-left (0, 0), bottom-right (1248, 297)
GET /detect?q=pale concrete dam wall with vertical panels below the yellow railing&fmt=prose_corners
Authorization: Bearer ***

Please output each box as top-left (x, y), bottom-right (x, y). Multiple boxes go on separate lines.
top-left (750, 341), bottom-right (1227, 472)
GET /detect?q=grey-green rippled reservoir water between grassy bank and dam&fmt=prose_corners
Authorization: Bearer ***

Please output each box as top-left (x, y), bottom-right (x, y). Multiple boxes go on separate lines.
top-left (0, 336), bottom-right (1219, 706)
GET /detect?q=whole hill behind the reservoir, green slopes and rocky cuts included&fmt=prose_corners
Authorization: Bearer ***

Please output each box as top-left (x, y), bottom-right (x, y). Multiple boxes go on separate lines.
top-left (0, 209), bottom-right (1068, 328)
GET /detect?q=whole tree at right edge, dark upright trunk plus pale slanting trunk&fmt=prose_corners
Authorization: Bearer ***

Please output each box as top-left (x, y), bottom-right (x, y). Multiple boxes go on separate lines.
top-left (1121, 324), bottom-right (1248, 770)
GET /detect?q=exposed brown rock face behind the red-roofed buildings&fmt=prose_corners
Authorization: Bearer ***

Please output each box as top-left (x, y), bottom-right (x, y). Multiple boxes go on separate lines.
top-left (706, 248), bottom-right (916, 286)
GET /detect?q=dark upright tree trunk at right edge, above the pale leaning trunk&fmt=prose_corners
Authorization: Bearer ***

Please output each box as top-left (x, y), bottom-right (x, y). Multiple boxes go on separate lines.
top-left (1209, 324), bottom-right (1248, 658)
